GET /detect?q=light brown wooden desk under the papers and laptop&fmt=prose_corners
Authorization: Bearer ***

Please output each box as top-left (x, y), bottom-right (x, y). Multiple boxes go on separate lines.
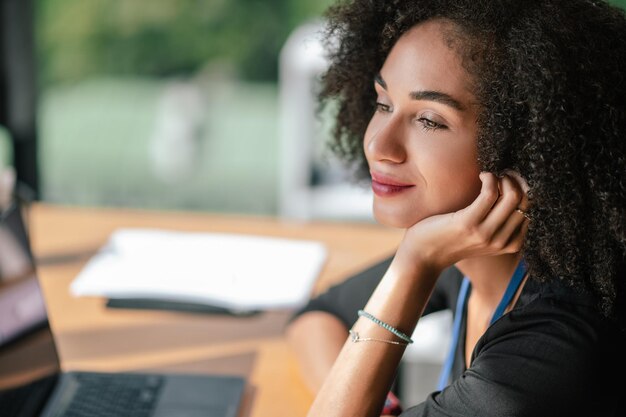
top-left (28, 204), bottom-right (401, 417)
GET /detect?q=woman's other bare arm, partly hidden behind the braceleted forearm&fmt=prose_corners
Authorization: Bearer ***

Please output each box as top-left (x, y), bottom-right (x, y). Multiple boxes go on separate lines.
top-left (286, 311), bottom-right (348, 393)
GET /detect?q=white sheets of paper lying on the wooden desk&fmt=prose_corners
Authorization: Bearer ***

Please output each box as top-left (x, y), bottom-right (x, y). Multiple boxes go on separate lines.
top-left (70, 229), bottom-right (327, 310)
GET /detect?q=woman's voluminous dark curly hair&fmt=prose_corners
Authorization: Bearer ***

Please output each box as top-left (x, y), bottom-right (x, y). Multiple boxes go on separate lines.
top-left (320, 0), bottom-right (626, 323)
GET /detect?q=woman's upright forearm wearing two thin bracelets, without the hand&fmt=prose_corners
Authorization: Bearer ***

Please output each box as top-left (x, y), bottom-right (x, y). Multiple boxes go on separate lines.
top-left (309, 260), bottom-right (439, 417)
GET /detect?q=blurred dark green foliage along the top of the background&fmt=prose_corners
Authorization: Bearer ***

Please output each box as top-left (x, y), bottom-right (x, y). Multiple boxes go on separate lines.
top-left (36, 0), bottom-right (330, 85)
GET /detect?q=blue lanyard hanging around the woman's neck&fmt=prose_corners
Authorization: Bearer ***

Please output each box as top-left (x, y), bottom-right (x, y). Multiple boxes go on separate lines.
top-left (437, 260), bottom-right (526, 391)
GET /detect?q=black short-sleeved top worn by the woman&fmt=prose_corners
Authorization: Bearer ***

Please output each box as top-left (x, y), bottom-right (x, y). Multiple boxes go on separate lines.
top-left (294, 259), bottom-right (626, 417)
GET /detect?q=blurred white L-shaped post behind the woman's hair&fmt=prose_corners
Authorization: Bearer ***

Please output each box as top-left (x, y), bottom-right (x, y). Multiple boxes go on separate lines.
top-left (278, 21), bottom-right (373, 220)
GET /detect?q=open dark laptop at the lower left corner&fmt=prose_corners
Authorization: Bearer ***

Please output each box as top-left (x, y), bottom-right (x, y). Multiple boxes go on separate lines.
top-left (0, 200), bottom-right (245, 417)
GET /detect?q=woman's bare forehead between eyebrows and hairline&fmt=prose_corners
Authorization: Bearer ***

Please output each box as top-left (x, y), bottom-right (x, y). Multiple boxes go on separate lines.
top-left (381, 20), bottom-right (473, 103)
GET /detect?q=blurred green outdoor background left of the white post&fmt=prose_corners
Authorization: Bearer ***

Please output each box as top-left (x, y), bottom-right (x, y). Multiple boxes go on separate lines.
top-left (0, 0), bottom-right (626, 214)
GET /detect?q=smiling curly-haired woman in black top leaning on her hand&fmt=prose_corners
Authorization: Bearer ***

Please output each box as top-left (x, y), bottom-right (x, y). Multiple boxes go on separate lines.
top-left (289, 0), bottom-right (626, 417)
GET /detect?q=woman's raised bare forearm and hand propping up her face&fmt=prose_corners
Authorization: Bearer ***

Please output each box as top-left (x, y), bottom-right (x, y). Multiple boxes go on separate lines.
top-left (309, 173), bottom-right (528, 417)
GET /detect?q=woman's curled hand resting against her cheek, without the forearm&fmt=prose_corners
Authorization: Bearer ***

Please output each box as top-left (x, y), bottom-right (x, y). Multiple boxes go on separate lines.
top-left (396, 172), bottom-right (529, 270)
